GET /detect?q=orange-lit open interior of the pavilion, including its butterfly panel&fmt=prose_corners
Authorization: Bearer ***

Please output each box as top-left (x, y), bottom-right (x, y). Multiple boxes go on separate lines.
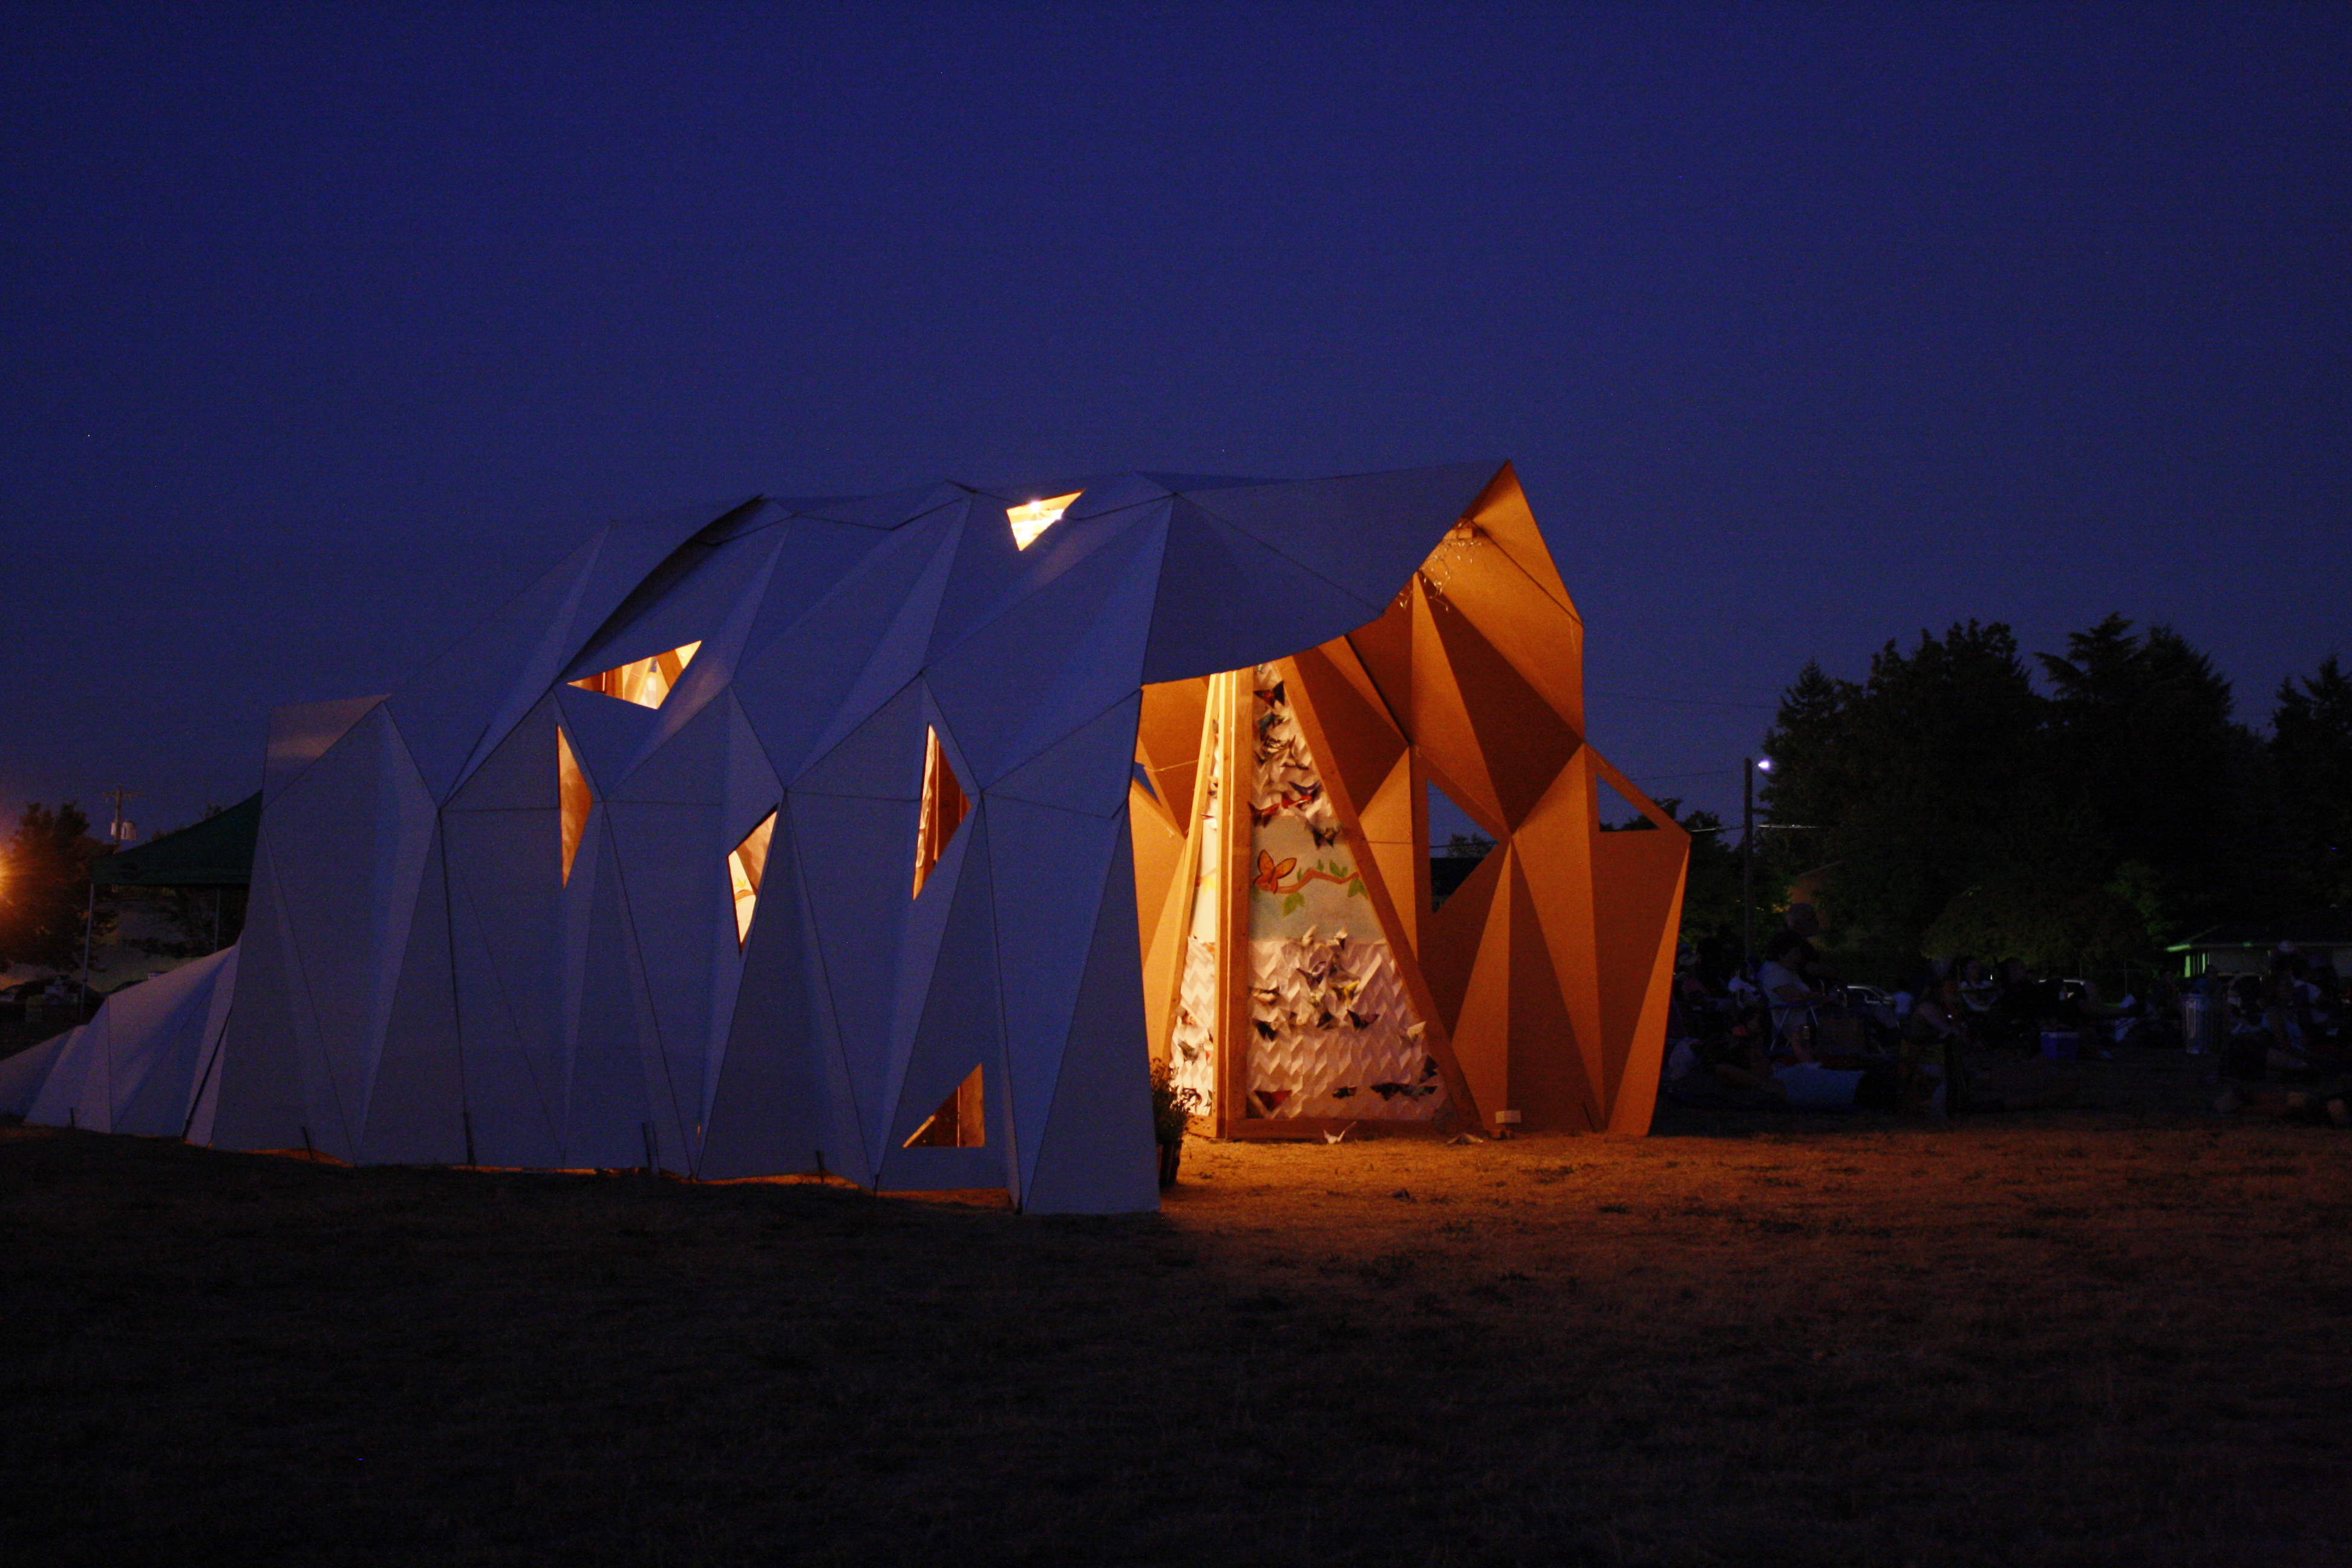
top-left (1129, 470), bottom-right (1689, 1138)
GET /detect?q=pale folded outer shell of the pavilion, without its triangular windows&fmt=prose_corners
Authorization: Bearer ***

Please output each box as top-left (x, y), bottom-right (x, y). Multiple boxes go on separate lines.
top-left (42, 463), bottom-right (1561, 1210)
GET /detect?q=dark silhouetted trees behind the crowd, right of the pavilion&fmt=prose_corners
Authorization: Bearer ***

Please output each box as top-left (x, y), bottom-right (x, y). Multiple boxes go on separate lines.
top-left (1757, 616), bottom-right (2352, 966)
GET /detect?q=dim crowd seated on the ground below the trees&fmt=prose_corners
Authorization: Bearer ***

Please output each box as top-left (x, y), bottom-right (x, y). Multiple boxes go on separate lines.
top-left (1663, 921), bottom-right (2352, 1126)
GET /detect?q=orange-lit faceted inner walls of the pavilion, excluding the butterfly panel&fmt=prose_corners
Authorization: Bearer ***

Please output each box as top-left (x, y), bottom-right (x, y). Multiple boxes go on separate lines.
top-left (1129, 470), bottom-right (1689, 1138)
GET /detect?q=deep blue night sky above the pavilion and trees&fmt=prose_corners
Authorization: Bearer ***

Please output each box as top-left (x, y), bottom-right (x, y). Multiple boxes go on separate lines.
top-left (0, 5), bottom-right (2352, 832)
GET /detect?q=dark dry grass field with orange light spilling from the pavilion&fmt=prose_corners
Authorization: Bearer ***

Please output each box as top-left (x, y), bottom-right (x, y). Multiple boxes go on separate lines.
top-left (0, 1048), bottom-right (2352, 1568)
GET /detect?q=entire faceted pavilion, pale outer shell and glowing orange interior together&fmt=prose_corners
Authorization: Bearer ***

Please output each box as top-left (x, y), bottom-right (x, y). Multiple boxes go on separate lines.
top-left (13, 463), bottom-right (1689, 1213)
